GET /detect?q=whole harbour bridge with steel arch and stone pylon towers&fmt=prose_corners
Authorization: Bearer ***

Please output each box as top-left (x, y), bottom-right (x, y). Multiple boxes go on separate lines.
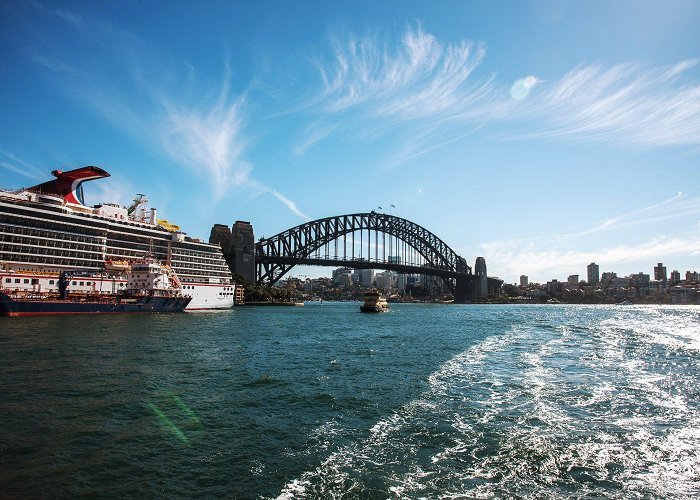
top-left (209, 211), bottom-right (502, 302)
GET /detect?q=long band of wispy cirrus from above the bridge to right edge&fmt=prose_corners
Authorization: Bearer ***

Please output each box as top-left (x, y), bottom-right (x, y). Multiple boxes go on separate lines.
top-left (296, 26), bottom-right (700, 163)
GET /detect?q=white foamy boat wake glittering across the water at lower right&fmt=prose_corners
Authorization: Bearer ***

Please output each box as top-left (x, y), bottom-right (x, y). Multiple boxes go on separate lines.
top-left (278, 306), bottom-right (700, 499)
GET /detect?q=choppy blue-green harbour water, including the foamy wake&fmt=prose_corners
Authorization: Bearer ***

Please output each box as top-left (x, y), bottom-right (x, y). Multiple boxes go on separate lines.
top-left (0, 303), bottom-right (700, 498)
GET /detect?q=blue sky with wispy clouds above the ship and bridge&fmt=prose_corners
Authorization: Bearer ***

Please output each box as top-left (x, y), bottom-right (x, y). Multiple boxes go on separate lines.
top-left (0, 0), bottom-right (700, 282)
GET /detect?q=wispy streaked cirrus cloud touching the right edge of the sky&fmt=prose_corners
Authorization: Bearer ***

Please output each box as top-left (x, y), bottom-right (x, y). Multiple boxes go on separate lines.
top-left (516, 60), bottom-right (700, 148)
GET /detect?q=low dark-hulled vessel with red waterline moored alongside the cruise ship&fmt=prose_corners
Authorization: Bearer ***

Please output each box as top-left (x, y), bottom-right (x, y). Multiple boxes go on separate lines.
top-left (0, 259), bottom-right (192, 316)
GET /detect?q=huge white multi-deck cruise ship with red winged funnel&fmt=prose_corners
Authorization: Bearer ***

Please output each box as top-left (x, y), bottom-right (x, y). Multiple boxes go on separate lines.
top-left (0, 166), bottom-right (236, 310)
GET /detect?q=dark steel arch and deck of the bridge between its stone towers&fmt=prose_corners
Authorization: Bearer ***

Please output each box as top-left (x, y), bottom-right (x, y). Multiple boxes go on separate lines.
top-left (255, 212), bottom-right (473, 292)
